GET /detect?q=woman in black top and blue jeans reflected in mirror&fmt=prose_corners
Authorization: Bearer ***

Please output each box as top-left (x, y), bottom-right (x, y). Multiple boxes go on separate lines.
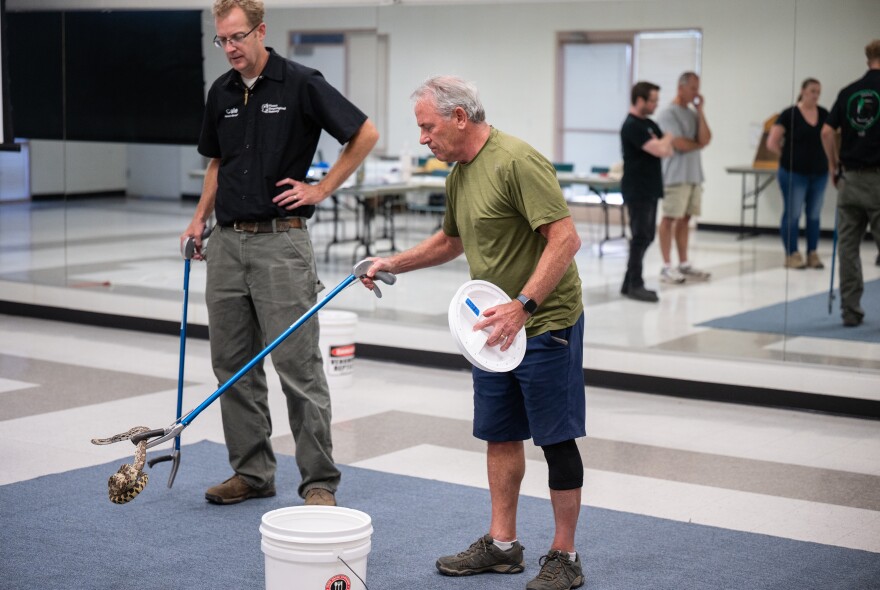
top-left (767, 78), bottom-right (828, 268)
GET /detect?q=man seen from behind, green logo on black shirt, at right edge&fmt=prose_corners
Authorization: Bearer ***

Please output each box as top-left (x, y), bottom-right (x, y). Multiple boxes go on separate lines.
top-left (822, 39), bottom-right (880, 327)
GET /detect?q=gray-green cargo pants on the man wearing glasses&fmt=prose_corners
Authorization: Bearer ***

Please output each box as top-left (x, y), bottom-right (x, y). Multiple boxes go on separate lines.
top-left (205, 228), bottom-right (340, 497)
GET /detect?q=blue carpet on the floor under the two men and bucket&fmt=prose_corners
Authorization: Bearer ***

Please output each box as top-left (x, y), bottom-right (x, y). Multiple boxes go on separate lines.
top-left (0, 442), bottom-right (880, 590)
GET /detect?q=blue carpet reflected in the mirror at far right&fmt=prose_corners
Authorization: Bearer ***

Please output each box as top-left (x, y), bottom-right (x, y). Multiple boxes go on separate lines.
top-left (697, 279), bottom-right (880, 343)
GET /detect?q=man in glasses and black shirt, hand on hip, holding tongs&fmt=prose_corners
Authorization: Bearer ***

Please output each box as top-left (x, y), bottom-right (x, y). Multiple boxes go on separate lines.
top-left (181, 0), bottom-right (378, 505)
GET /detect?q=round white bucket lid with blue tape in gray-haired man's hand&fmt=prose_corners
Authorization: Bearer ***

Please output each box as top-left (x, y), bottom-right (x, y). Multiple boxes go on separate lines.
top-left (449, 280), bottom-right (526, 373)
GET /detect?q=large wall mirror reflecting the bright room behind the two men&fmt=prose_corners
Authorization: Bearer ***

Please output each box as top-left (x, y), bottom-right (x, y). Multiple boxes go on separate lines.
top-left (0, 0), bottom-right (880, 414)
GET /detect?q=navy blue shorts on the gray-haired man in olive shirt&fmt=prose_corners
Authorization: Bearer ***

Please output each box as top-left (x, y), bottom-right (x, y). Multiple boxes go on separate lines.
top-left (473, 314), bottom-right (586, 446)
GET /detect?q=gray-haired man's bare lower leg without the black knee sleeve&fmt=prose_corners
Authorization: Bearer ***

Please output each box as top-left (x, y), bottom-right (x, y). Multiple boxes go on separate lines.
top-left (486, 441), bottom-right (526, 541)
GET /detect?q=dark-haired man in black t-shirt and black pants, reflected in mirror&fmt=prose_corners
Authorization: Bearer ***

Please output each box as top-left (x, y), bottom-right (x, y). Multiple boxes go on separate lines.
top-left (620, 82), bottom-right (673, 303)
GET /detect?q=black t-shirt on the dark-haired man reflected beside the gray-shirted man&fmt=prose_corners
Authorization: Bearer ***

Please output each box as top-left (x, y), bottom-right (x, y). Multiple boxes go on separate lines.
top-left (620, 113), bottom-right (663, 202)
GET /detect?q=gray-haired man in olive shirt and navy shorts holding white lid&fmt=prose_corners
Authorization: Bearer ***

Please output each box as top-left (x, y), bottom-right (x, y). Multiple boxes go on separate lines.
top-left (365, 76), bottom-right (586, 590)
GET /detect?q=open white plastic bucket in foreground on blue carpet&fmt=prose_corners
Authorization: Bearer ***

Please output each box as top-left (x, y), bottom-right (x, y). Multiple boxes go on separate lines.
top-left (260, 506), bottom-right (373, 590)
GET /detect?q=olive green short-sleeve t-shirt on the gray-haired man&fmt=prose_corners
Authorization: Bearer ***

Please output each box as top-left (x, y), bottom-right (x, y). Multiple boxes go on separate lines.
top-left (443, 128), bottom-right (583, 338)
